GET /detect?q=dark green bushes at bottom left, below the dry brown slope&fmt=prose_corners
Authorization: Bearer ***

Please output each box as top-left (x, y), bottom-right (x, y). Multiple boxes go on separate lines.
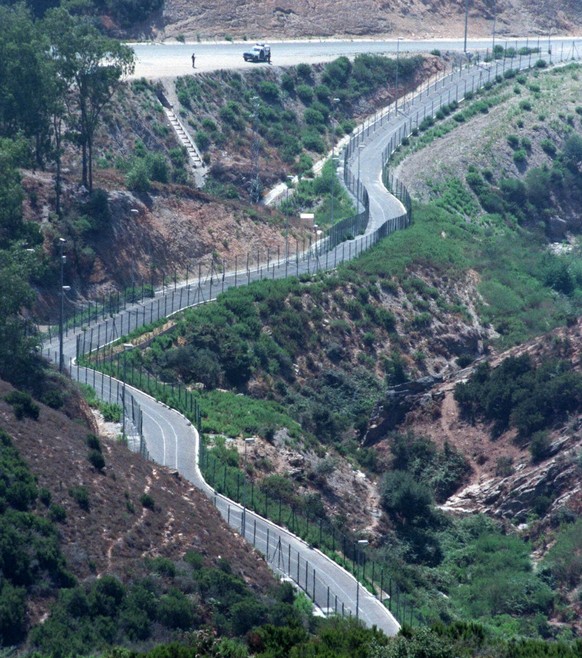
top-left (29, 552), bottom-right (310, 658)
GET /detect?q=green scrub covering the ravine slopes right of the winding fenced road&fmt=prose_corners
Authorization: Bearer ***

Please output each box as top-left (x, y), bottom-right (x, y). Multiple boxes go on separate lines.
top-left (92, 62), bottom-right (582, 640)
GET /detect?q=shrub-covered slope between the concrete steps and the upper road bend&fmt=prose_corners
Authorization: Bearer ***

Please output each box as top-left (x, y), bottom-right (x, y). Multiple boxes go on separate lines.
top-left (176, 55), bottom-right (423, 205)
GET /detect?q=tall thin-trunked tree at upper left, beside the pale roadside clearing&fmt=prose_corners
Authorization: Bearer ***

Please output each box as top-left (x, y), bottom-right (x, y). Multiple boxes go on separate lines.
top-left (44, 8), bottom-right (135, 191)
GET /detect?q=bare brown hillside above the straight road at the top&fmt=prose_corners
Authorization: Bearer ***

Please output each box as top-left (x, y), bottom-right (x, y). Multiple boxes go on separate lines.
top-left (149, 0), bottom-right (582, 40)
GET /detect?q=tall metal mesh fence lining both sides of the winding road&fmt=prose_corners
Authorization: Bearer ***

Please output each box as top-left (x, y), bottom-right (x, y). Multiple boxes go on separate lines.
top-left (45, 42), bottom-right (578, 621)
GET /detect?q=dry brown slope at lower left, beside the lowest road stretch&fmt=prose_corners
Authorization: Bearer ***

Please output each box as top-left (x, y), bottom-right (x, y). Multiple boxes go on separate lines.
top-left (0, 382), bottom-right (275, 648)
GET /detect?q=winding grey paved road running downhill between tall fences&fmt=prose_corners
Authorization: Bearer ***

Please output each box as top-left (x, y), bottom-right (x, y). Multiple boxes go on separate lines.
top-left (44, 41), bottom-right (582, 635)
